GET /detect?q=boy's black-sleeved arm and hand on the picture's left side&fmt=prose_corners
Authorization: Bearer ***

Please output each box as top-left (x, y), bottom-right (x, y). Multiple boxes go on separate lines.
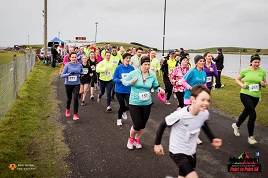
top-left (154, 120), bottom-right (167, 155)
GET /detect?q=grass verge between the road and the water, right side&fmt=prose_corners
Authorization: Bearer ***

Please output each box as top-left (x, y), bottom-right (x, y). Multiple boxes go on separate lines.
top-left (157, 76), bottom-right (268, 127)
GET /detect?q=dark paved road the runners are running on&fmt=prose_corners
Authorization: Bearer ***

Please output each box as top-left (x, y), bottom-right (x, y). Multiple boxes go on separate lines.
top-left (56, 79), bottom-right (268, 178)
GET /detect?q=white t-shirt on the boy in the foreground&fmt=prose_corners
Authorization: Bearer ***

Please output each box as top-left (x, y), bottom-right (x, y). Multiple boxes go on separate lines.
top-left (165, 107), bottom-right (209, 155)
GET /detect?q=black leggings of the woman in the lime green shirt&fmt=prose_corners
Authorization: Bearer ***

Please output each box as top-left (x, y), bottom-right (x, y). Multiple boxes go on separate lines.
top-left (236, 93), bottom-right (259, 136)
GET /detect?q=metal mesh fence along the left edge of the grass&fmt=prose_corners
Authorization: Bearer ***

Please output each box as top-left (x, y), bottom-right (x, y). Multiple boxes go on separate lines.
top-left (0, 53), bottom-right (36, 121)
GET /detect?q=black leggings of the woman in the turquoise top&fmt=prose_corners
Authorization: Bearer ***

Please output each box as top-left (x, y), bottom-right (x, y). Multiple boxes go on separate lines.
top-left (129, 104), bottom-right (151, 131)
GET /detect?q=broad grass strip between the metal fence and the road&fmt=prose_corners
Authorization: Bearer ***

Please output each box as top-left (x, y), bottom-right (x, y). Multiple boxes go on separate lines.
top-left (0, 62), bottom-right (69, 178)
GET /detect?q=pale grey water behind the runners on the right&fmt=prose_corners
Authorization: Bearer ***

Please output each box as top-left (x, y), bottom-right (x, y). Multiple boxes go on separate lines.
top-left (156, 53), bottom-right (268, 79)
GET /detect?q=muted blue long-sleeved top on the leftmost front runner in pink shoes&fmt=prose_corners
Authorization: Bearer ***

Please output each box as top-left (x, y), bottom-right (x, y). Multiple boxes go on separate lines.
top-left (60, 62), bottom-right (84, 85)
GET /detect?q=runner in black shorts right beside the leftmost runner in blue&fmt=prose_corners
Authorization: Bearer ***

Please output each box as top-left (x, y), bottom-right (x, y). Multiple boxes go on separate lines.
top-left (79, 55), bottom-right (93, 106)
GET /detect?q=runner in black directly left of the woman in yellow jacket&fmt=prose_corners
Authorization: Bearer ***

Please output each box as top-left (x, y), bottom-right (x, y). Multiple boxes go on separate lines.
top-left (88, 51), bottom-right (98, 100)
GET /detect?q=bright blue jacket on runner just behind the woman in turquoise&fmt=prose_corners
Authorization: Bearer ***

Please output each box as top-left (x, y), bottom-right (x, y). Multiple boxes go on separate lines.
top-left (113, 64), bottom-right (134, 94)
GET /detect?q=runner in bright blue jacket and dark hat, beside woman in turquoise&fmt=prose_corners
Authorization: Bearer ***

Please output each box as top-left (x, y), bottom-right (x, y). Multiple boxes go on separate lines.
top-left (113, 53), bottom-right (134, 126)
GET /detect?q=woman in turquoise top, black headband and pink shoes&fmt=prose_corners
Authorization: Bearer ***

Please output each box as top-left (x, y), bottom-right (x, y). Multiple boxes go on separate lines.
top-left (123, 56), bottom-right (165, 149)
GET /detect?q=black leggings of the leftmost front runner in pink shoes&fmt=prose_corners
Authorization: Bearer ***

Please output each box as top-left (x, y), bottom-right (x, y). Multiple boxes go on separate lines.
top-left (65, 85), bottom-right (80, 114)
